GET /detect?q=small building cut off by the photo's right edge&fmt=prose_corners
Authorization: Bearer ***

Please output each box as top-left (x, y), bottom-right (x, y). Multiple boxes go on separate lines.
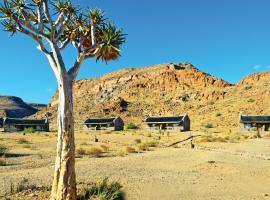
top-left (240, 115), bottom-right (270, 131)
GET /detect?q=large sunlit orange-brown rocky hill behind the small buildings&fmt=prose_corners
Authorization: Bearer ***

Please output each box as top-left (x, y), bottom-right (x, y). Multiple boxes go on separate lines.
top-left (31, 63), bottom-right (270, 131)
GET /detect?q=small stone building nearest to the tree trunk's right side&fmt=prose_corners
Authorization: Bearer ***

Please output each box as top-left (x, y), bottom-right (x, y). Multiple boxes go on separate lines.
top-left (84, 117), bottom-right (124, 131)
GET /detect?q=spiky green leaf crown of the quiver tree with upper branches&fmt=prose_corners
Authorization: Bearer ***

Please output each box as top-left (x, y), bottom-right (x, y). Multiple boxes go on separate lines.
top-left (0, 0), bottom-right (125, 66)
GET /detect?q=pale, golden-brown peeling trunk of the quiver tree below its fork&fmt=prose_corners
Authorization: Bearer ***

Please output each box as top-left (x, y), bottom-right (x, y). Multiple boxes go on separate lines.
top-left (51, 73), bottom-right (76, 200)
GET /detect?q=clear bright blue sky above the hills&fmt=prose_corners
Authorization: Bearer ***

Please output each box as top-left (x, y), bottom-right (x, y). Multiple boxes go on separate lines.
top-left (0, 0), bottom-right (270, 103)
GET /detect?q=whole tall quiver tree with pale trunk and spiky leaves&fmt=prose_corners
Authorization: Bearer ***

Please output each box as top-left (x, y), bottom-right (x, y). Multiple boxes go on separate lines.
top-left (0, 0), bottom-right (125, 200)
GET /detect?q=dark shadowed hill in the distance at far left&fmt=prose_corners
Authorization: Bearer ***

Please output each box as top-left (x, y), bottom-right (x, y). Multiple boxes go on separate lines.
top-left (0, 96), bottom-right (42, 118)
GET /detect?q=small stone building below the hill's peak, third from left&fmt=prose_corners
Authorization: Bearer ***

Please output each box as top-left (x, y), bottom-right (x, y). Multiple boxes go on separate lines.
top-left (144, 114), bottom-right (190, 131)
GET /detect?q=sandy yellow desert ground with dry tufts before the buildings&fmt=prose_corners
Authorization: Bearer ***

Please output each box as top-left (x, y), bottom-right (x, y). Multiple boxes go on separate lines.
top-left (0, 130), bottom-right (270, 200)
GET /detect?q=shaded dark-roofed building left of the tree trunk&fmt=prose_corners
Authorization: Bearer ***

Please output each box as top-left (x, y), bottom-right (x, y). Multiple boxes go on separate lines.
top-left (3, 118), bottom-right (49, 132)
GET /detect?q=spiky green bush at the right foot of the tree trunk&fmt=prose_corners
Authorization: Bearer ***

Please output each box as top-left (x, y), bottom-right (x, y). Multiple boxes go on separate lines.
top-left (77, 178), bottom-right (124, 200)
